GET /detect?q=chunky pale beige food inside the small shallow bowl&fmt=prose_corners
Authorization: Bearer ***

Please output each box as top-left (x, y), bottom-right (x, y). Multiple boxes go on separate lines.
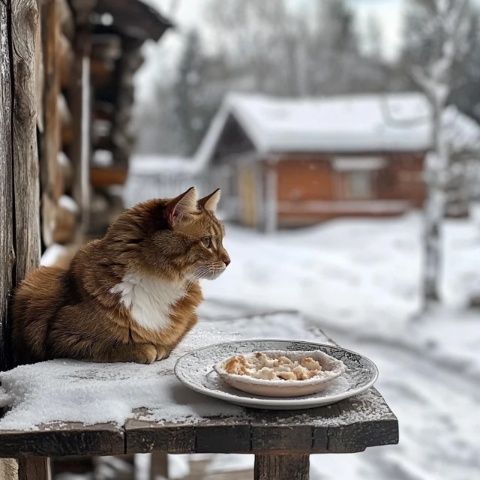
top-left (225, 352), bottom-right (322, 380)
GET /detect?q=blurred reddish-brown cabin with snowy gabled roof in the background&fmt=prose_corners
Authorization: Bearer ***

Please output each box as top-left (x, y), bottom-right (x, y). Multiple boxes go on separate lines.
top-left (197, 93), bottom-right (479, 230)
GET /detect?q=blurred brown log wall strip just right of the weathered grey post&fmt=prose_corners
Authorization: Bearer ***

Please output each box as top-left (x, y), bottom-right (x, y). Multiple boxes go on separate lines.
top-left (39, 0), bottom-right (85, 258)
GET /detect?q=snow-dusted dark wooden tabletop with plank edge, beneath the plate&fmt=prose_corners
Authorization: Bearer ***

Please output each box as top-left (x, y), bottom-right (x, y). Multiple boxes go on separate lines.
top-left (0, 313), bottom-right (398, 464)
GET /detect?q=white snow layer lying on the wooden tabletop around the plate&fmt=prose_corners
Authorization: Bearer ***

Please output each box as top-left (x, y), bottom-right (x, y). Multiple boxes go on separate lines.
top-left (0, 314), bottom-right (326, 430)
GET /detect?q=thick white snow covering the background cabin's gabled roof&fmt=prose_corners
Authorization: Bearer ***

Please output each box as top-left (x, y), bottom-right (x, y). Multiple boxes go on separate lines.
top-left (195, 93), bottom-right (480, 165)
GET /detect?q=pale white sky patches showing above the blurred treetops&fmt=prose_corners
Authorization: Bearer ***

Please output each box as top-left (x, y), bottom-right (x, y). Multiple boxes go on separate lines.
top-left (137, 0), bottom-right (406, 98)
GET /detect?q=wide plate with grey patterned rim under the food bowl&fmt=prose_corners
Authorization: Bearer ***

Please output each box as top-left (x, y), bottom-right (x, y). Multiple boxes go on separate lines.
top-left (175, 340), bottom-right (378, 410)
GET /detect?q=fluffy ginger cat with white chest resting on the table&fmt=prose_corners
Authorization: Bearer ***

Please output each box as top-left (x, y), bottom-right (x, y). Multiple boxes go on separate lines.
top-left (12, 187), bottom-right (230, 363)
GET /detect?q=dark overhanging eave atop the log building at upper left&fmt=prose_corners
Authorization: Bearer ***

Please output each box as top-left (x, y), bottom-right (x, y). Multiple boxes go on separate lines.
top-left (95, 0), bottom-right (173, 42)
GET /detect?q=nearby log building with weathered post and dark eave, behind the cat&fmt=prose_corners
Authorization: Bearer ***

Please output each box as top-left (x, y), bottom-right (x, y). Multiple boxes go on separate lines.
top-left (0, 0), bottom-right (171, 370)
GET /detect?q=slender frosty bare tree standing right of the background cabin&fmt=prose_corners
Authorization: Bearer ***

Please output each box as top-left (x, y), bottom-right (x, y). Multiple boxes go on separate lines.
top-left (405, 0), bottom-right (470, 309)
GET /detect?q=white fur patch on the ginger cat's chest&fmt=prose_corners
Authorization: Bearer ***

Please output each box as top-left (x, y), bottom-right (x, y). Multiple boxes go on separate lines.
top-left (110, 273), bottom-right (185, 331)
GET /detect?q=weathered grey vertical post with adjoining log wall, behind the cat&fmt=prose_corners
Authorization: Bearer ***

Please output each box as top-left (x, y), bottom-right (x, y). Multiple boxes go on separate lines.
top-left (0, 0), bottom-right (94, 369)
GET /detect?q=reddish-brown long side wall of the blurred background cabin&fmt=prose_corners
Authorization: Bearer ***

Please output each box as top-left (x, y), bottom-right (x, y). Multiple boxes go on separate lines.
top-left (266, 153), bottom-right (425, 226)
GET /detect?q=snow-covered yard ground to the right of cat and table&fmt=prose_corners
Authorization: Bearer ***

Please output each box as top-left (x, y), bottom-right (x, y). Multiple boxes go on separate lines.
top-left (195, 214), bottom-right (480, 480)
